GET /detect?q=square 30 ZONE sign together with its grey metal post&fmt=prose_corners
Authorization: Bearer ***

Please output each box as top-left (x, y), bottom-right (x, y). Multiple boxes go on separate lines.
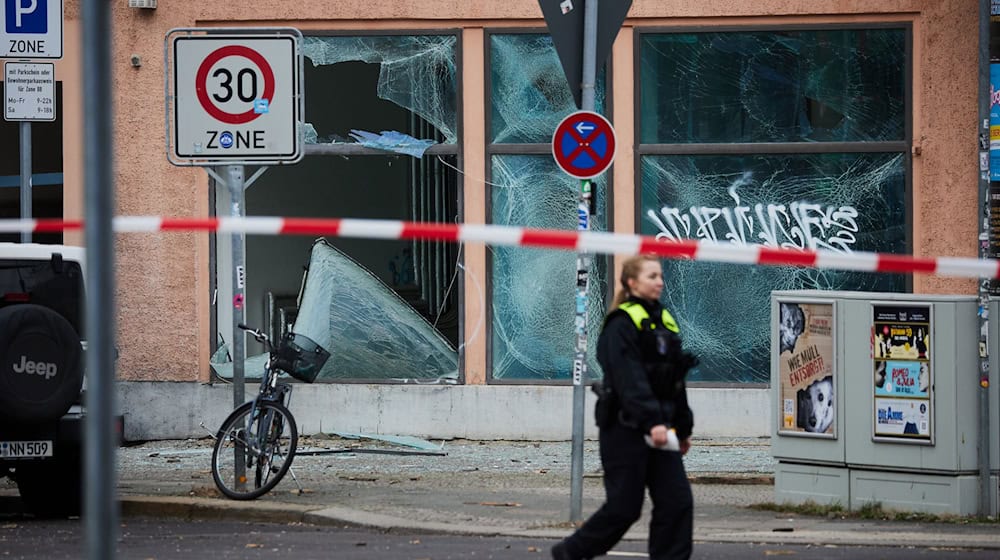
top-left (164, 27), bottom-right (305, 494)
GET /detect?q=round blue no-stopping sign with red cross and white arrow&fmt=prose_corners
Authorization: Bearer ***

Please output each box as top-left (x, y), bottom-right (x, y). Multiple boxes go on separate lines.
top-left (552, 111), bottom-right (615, 179)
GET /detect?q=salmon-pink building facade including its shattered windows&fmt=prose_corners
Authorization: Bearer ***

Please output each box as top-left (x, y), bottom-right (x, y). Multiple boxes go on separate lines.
top-left (0, 0), bottom-right (978, 434)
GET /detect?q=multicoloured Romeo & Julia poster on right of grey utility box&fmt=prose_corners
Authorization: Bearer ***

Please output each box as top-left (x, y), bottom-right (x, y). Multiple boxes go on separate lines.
top-left (871, 304), bottom-right (932, 443)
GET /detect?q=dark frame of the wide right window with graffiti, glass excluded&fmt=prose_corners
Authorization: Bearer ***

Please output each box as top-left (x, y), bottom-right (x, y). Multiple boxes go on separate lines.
top-left (633, 22), bottom-right (913, 388)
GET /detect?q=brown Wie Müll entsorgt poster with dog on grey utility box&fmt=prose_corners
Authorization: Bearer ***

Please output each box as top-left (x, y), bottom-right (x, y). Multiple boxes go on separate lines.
top-left (778, 301), bottom-right (837, 437)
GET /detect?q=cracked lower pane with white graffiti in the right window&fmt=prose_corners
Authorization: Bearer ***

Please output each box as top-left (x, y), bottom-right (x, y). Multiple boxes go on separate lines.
top-left (639, 153), bottom-right (908, 383)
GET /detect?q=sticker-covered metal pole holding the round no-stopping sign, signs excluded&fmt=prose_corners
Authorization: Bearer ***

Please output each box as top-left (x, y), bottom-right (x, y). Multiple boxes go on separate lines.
top-left (569, 0), bottom-right (598, 522)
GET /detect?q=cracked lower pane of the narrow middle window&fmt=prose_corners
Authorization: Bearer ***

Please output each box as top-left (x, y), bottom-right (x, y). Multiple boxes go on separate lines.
top-left (490, 155), bottom-right (608, 379)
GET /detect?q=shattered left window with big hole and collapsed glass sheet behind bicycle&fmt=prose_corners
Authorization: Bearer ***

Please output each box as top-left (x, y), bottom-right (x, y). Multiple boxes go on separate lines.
top-left (212, 34), bottom-right (462, 383)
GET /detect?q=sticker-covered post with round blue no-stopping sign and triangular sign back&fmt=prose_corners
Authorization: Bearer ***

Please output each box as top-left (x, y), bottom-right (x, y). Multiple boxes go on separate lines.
top-left (538, 0), bottom-right (632, 522)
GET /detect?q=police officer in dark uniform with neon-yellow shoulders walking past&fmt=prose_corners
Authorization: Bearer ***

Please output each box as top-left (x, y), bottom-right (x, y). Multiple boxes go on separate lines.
top-left (552, 255), bottom-right (697, 560)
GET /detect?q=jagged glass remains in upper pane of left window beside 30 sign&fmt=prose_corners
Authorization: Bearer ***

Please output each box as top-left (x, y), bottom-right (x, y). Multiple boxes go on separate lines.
top-left (302, 35), bottom-right (458, 144)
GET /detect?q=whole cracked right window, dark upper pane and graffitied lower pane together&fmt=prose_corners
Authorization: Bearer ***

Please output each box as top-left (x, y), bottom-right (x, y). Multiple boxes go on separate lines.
top-left (637, 28), bottom-right (910, 383)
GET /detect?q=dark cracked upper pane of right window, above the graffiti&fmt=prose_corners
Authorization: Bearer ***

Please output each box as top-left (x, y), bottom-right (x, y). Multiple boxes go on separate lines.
top-left (639, 29), bottom-right (907, 144)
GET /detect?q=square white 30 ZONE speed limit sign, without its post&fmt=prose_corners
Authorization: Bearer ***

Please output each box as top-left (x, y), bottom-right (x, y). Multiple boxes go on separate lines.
top-left (167, 29), bottom-right (303, 165)
